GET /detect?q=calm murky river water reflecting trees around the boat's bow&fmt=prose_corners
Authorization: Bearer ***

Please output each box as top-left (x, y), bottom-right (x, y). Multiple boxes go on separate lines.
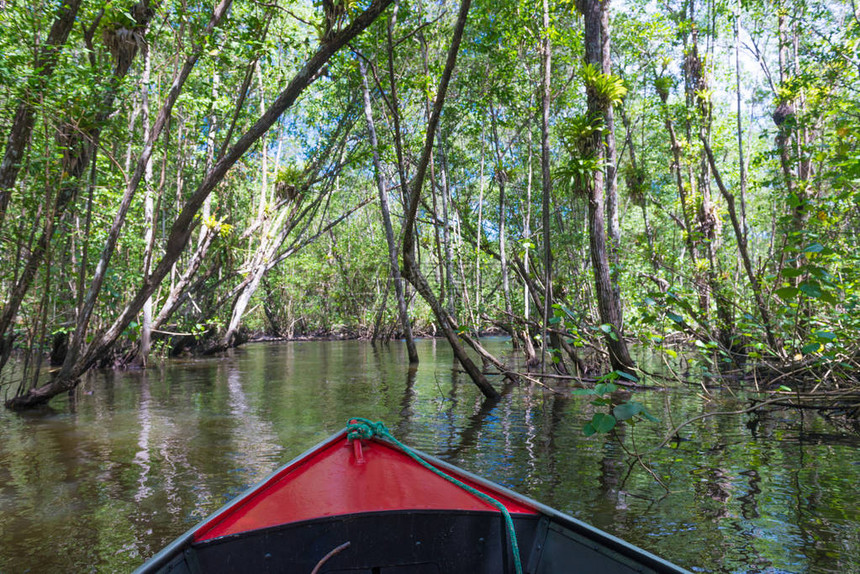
top-left (0, 339), bottom-right (860, 573)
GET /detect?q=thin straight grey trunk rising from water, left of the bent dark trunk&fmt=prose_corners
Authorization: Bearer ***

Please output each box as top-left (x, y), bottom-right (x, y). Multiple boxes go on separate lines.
top-left (358, 59), bottom-right (418, 365)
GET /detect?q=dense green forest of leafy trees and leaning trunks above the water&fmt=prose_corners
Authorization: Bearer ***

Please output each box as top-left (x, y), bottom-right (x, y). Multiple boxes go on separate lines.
top-left (0, 0), bottom-right (860, 416)
